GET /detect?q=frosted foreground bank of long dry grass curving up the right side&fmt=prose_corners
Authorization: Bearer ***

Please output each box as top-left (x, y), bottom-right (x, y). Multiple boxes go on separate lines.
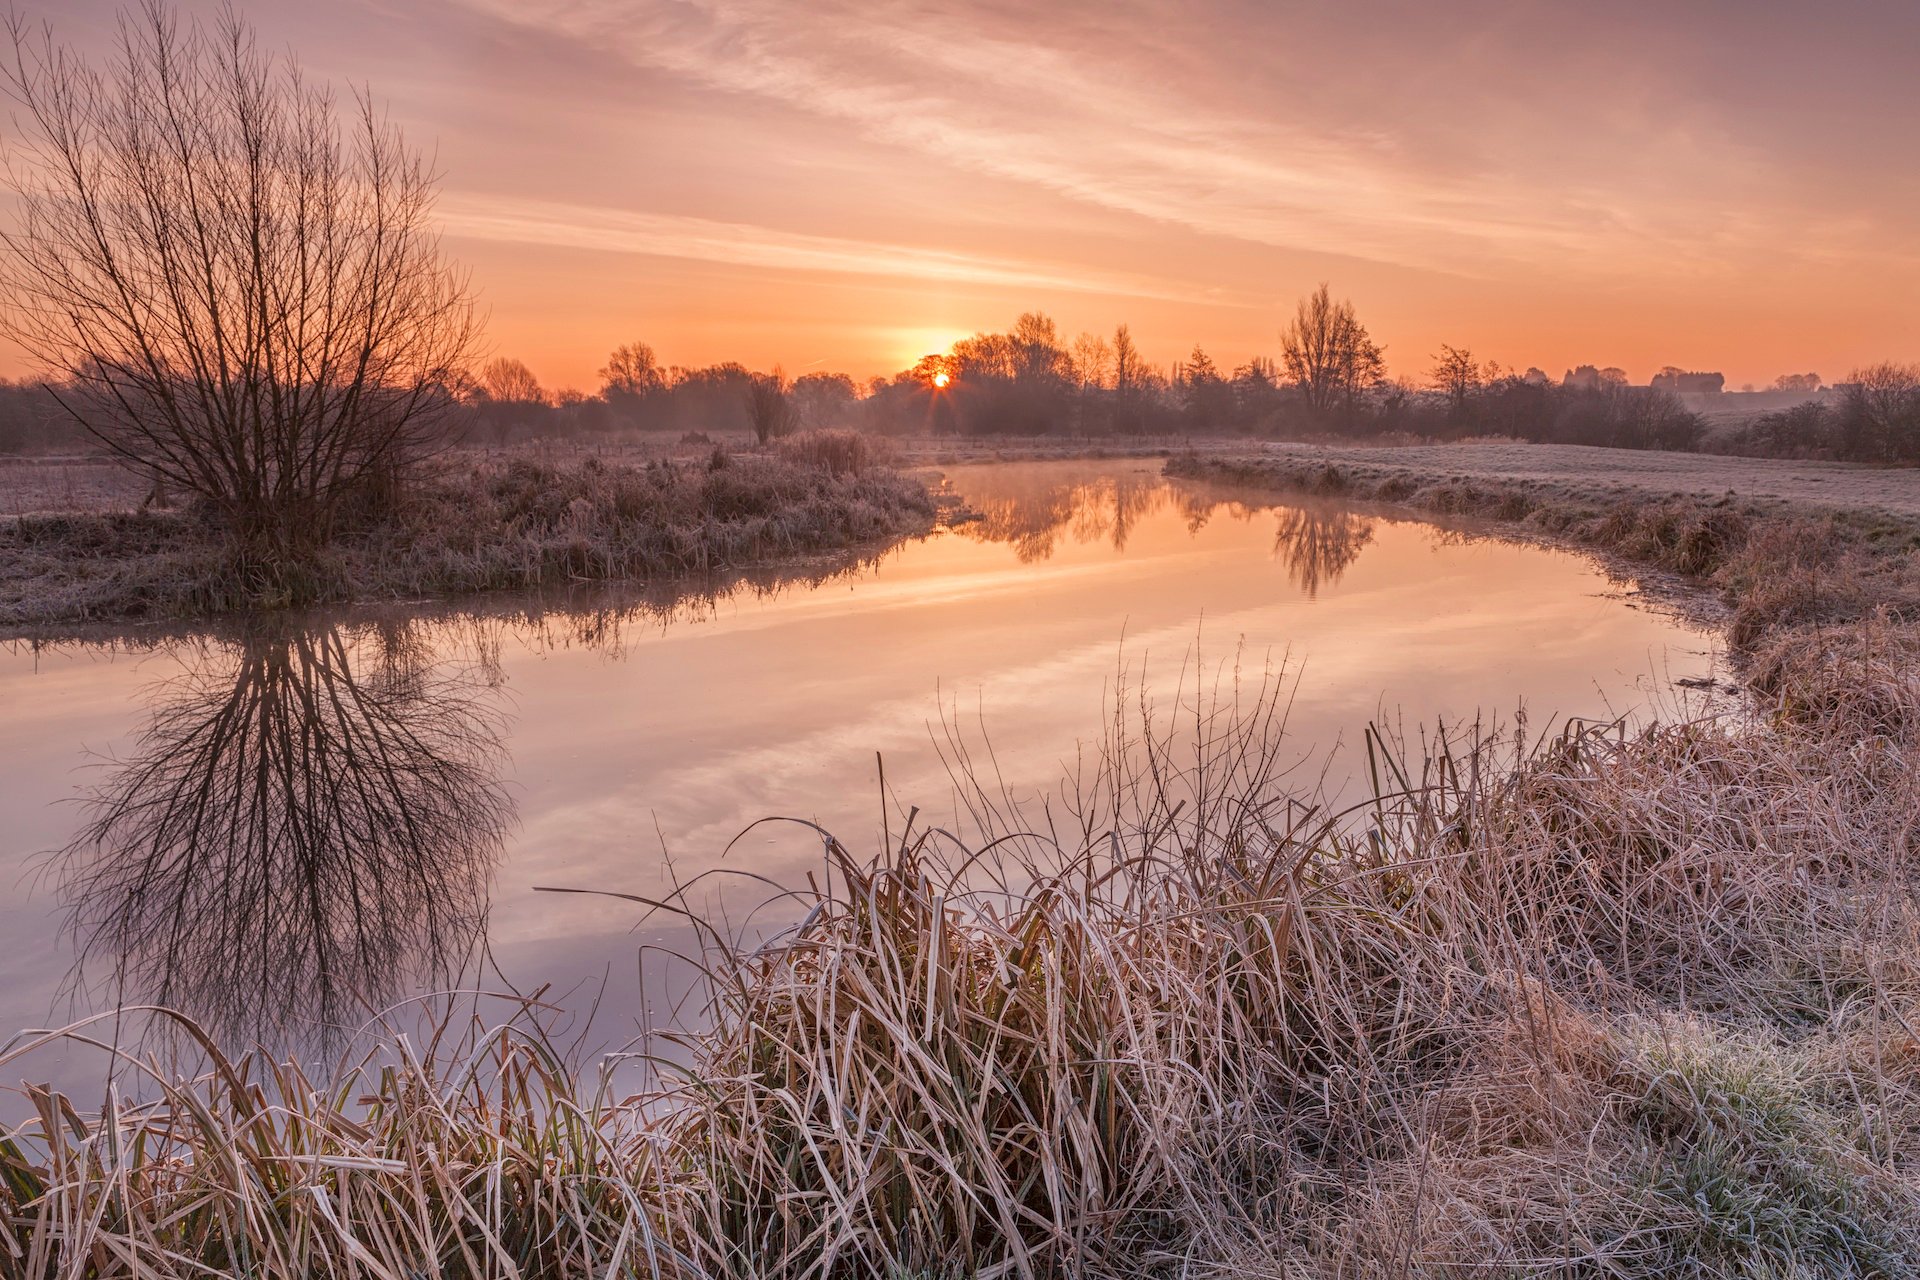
top-left (0, 445), bottom-right (1920, 1280)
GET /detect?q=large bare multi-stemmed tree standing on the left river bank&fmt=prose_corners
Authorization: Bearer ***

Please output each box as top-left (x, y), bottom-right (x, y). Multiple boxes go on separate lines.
top-left (0, 0), bottom-right (476, 564)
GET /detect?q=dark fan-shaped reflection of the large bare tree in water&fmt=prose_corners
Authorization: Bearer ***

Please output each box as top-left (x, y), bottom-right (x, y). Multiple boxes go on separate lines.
top-left (63, 622), bottom-right (513, 1042)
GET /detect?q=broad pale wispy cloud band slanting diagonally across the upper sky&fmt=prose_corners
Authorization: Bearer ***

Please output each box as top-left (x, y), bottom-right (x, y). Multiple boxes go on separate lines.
top-left (445, 0), bottom-right (1827, 274)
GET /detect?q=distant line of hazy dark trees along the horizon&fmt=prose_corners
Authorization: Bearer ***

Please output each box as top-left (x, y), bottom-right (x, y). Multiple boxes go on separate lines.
top-left (15, 286), bottom-right (1920, 462)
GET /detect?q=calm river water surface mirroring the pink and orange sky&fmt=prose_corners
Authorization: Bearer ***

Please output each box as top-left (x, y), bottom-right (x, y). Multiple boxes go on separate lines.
top-left (0, 462), bottom-right (1713, 1079)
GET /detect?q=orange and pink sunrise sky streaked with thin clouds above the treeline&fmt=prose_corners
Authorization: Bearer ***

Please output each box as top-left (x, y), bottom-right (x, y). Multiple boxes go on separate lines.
top-left (0, 0), bottom-right (1920, 390)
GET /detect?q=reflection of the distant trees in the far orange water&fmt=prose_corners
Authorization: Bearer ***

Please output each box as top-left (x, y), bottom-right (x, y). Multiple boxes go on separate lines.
top-left (962, 468), bottom-right (1373, 599)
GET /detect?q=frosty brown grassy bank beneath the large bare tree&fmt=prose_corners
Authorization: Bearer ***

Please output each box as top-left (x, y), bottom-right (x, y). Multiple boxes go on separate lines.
top-left (0, 441), bottom-right (933, 628)
